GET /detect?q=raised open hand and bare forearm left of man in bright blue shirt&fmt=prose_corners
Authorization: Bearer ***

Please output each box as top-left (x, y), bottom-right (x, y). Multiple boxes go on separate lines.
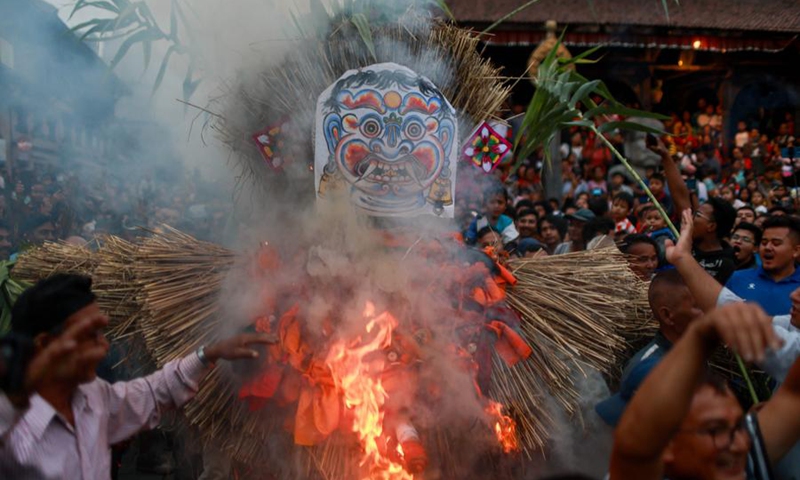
top-left (666, 209), bottom-right (722, 312)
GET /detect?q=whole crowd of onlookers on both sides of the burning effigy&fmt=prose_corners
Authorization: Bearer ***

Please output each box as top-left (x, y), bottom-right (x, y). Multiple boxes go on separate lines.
top-left (0, 94), bottom-right (800, 480)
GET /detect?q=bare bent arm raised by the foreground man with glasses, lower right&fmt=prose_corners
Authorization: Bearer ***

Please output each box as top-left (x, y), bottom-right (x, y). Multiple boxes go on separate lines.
top-left (610, 303), bottom-right (780, 480)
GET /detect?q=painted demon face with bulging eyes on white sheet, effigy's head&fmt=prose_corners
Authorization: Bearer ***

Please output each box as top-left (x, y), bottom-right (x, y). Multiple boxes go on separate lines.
top-left (315, 63), bottom-right (458, 217)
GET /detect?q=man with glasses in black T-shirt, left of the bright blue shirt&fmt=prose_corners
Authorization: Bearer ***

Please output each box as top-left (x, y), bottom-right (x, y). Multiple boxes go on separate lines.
top-left (692, 198), bottom-right (736, 284)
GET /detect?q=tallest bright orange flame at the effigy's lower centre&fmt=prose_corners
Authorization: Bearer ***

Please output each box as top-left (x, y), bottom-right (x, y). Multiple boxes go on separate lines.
top-left (326, 302), bottom-right (414, 480)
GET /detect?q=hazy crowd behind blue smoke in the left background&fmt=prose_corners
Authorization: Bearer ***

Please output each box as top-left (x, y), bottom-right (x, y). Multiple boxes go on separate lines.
top-left (0, 162), bottom-right (230, 260)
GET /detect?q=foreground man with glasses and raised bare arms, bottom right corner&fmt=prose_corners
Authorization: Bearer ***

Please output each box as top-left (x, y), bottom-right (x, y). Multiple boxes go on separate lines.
top-left (610, 303), bottom-right (800, 480)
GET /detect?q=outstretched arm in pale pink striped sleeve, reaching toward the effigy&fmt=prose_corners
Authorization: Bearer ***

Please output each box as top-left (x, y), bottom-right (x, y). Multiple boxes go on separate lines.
top-left (105, 334), bottom-right (277, 444)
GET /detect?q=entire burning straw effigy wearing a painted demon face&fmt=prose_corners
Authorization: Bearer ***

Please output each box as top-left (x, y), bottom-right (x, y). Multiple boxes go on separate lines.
top-left (14, 4), bottom-right (652, 480)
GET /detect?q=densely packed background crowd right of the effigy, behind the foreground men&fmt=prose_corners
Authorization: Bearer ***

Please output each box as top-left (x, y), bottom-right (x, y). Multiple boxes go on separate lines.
top-left (458, 99), bottom-right (800, 283)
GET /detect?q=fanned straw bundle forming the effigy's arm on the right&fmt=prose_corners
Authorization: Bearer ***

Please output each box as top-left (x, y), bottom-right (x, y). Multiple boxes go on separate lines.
top-left (500, 247), bottom-right (655, 451)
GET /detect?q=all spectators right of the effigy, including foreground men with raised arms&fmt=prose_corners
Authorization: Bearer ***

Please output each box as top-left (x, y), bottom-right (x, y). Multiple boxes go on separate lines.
top-left (458, 100), bottom-right (800, 480)
